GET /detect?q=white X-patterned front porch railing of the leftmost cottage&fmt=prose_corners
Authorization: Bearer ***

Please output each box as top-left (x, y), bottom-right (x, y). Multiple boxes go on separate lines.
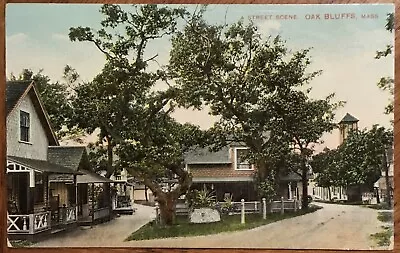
top-left (7, 211), bottom-right (51, 234)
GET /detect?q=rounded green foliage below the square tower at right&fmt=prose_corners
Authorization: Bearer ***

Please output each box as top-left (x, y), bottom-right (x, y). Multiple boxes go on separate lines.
top-left (311, 125), bottom-right (393, 187)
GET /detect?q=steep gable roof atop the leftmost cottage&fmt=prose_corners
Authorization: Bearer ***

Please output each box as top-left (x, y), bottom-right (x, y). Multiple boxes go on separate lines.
top-left (6, 81), bottom-right (59, 145)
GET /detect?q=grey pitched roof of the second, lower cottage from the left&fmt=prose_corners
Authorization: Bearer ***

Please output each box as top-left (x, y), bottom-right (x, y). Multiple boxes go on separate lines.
top-left (48, 146), bottom-right (89, 171)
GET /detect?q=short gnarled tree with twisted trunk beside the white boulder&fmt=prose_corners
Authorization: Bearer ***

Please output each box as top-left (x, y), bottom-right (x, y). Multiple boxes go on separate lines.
top-left (118, 115), bottom-right (206, 225)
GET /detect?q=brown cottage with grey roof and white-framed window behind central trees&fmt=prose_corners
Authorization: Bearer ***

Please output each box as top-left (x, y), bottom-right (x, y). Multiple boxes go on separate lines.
top-left (185, 145), bottom-right (301, 201)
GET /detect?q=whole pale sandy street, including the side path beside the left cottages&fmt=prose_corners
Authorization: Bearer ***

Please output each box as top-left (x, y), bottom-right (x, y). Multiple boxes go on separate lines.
top-left (34, 203), bottom-right (387, 249)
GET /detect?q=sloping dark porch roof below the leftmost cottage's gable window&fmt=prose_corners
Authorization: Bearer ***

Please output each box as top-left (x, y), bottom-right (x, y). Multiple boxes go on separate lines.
top-left (7, 156), bottom-right (82, 175)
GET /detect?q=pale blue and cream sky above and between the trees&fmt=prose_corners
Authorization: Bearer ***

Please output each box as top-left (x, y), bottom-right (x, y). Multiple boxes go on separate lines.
top-left (6, 4), bottom-right (394, 148)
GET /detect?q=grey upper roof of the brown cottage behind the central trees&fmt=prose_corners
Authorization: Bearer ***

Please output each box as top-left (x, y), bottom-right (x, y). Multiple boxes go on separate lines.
top-left (185, 146), bottom-right (232, 164)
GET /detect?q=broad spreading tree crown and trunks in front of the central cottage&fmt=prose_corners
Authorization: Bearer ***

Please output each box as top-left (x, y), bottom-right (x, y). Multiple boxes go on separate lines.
top-left (169, 8), bottom-right (337, 208)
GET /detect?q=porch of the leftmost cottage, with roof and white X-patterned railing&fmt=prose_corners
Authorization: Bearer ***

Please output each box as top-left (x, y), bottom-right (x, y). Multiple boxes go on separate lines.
top-left (7, 157), bottom-right (78, 240)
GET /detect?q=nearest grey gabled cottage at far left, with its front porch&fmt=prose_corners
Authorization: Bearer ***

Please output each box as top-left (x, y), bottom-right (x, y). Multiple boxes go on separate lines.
top-left (6, 81), bottom-right (81, 239)
